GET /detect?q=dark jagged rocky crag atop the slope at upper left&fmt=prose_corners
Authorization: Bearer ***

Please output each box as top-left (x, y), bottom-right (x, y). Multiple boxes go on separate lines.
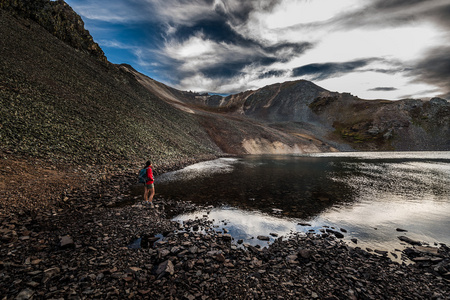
top-left (0, 0), bottom-right (107, 62)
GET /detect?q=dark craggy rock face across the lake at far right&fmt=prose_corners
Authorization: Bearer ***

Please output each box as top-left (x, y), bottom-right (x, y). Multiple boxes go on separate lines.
top-left (309, 94), bottom-right (450, 151)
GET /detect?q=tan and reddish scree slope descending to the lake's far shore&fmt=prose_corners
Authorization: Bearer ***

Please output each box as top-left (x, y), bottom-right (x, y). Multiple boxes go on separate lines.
top-left (121, 65), bottom-right (336, 154)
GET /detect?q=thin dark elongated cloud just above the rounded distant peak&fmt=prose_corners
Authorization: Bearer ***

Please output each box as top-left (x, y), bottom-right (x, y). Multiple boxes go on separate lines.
top-left (292, 58), bottom-right (377, 80)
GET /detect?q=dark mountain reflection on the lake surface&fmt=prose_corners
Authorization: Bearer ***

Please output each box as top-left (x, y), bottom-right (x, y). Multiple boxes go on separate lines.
top-left (157, 156), bottom-right (355, 219)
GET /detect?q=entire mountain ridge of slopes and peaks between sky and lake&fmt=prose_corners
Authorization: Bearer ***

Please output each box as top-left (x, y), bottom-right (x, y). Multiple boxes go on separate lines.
top-left (0, 0), bottom-right (450, 166)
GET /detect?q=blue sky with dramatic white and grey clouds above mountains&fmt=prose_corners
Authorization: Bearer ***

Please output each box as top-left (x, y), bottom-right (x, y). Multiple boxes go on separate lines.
top-left (66, 0), bottom-right (450, 100)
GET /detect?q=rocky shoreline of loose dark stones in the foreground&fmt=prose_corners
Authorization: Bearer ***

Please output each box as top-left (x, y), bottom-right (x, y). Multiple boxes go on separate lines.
top-left (0, 158), bottom-right (450, 299)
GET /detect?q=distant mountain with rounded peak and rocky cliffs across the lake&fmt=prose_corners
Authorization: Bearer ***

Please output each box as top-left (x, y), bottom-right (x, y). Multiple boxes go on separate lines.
top-left (163, 75), bottom-right (450, 151)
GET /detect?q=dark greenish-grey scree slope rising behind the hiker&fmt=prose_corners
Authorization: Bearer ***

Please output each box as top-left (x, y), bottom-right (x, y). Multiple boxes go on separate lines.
top-left (0, 10), bottom-right (219, 163)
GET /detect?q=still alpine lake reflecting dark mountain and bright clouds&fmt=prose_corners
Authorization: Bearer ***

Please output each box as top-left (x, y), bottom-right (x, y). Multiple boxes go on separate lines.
top-left (156, 152), bottom-right (450, 255)
